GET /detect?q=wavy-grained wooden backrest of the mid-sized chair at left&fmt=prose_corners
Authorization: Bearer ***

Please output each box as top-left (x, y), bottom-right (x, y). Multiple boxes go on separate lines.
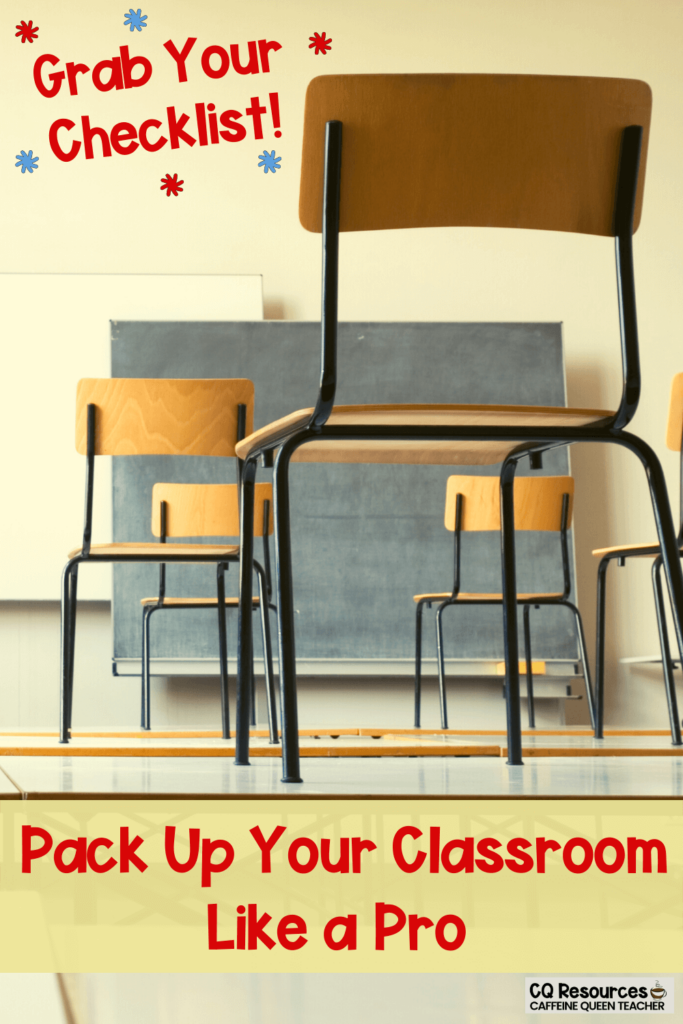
top-left (76, 377), bottom-right (254, 457)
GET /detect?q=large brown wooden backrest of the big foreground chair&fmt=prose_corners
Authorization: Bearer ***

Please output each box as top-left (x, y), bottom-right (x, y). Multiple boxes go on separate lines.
top-left (299, 75), bottom-right (651, 234)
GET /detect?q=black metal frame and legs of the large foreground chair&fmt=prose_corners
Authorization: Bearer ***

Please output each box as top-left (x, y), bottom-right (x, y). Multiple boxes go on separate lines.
top-left (236, 105), bottom-right (683, 782)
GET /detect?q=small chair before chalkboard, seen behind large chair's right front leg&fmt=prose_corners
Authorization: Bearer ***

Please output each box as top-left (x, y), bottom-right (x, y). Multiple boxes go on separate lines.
top-left (413, 476), bottom-right (594, 729)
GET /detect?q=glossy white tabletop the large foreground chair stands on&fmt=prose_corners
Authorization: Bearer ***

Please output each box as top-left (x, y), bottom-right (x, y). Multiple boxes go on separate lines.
top-left (0, 755), bottom-right (683, 800)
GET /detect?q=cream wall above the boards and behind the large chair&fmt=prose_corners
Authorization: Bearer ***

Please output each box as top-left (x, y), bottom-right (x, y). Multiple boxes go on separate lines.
top-left (0, 0), bottom-right (683, 725)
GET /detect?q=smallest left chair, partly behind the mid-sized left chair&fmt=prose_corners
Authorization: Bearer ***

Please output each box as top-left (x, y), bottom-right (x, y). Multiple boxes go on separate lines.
top-left (140, 483), bottom-right (278, 743)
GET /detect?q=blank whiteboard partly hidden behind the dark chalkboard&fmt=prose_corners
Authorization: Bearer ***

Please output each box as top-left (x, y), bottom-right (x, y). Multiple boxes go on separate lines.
top-left (0, 273), bottom-right (263, 601)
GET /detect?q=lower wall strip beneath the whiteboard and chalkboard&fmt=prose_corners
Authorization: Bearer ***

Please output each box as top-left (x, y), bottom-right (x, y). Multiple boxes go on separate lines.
top-left (0, 601), bottom-right (581, 730)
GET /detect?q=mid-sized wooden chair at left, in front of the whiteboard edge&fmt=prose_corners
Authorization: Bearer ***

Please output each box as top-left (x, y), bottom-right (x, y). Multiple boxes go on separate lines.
top-left (59, 378), bottom-right (254, 743)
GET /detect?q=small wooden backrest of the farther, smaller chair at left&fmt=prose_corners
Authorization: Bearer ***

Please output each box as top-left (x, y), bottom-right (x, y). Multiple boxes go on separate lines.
top-left (152, 483), bottom-right (272, 537)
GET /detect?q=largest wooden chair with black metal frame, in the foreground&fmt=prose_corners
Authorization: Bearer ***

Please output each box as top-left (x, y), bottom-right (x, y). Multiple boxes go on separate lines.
top-left (236, 74), bottom-right (683, 782)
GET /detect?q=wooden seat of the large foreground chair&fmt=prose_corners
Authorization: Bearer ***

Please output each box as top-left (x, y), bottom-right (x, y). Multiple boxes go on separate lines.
top-left (236, 406), bottom-right (614, 466)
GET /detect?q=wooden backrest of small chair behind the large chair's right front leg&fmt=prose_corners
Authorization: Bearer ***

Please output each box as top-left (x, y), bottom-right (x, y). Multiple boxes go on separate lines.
top-left (443, 476), bottom-right (573, 532)
